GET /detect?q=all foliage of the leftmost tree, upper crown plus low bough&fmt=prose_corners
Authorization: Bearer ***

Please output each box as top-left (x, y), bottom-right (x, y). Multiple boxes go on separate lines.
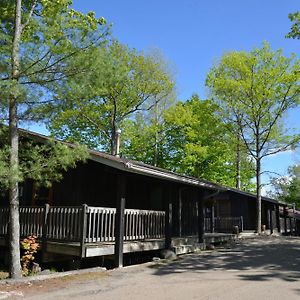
top-left (0, 0), bottom-right (109, 189)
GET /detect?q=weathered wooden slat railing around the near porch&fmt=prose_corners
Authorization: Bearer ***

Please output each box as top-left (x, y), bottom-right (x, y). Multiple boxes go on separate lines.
top-left (0, 205), bottom-right (165, 243)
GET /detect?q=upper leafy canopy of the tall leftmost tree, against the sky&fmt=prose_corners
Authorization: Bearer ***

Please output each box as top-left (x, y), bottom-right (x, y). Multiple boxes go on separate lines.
top-left (0, 0), bottom-right (109, 120)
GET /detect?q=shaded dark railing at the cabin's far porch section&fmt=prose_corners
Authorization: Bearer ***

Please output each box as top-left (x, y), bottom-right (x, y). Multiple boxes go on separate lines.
top-left (204, 217), bottom-right (244, 233)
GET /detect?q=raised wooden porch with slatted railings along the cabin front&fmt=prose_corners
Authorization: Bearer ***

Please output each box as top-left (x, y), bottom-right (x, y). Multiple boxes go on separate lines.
top-left (0, 204), bottom-right (239, 258)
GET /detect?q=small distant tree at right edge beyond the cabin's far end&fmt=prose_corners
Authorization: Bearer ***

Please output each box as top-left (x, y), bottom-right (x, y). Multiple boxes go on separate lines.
top-left (270, 165), bottom-right (300, 209)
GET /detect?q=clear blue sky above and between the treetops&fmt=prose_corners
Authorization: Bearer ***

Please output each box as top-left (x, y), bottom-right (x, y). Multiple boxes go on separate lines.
top-left (35, 0), bottom-right (300, 191)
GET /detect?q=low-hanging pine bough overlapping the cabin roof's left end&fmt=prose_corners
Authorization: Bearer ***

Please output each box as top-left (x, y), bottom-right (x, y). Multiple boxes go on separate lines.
top-left (0, 127), bottom-right (89, 191)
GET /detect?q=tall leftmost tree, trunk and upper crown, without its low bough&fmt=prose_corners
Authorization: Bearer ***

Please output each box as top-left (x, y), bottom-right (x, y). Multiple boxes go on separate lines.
top-left (0, 0), bottom-right (106, 278)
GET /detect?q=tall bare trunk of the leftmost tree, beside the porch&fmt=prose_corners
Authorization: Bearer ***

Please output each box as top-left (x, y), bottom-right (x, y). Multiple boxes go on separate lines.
top-left (9, 0), bottom-right (22, 278)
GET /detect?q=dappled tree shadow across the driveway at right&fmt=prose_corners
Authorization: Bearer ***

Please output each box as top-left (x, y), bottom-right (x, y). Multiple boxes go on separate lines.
top-left (152, 237), bottom-right (300, 282)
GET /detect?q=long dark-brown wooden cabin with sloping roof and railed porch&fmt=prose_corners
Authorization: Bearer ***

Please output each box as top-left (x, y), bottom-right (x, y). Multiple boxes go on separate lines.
top-left (0, 130), bottom-right (297, 266)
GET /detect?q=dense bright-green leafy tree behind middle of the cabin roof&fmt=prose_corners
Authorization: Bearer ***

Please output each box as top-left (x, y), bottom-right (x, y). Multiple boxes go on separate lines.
top-left (164, 95), bottom-right (253, 190)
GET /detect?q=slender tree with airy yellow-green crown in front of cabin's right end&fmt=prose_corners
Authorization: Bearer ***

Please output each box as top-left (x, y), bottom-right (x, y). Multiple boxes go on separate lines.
top-left (207, 43), bottom-right (300, 233)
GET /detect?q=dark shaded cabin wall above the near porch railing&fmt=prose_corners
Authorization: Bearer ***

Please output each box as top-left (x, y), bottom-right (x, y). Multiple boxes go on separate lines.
top-left (12, 161), bottom-right (164, 210)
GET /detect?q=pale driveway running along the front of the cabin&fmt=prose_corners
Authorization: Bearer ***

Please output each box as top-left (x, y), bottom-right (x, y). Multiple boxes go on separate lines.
top-left (0, 237), bottom-right (300, 300)
